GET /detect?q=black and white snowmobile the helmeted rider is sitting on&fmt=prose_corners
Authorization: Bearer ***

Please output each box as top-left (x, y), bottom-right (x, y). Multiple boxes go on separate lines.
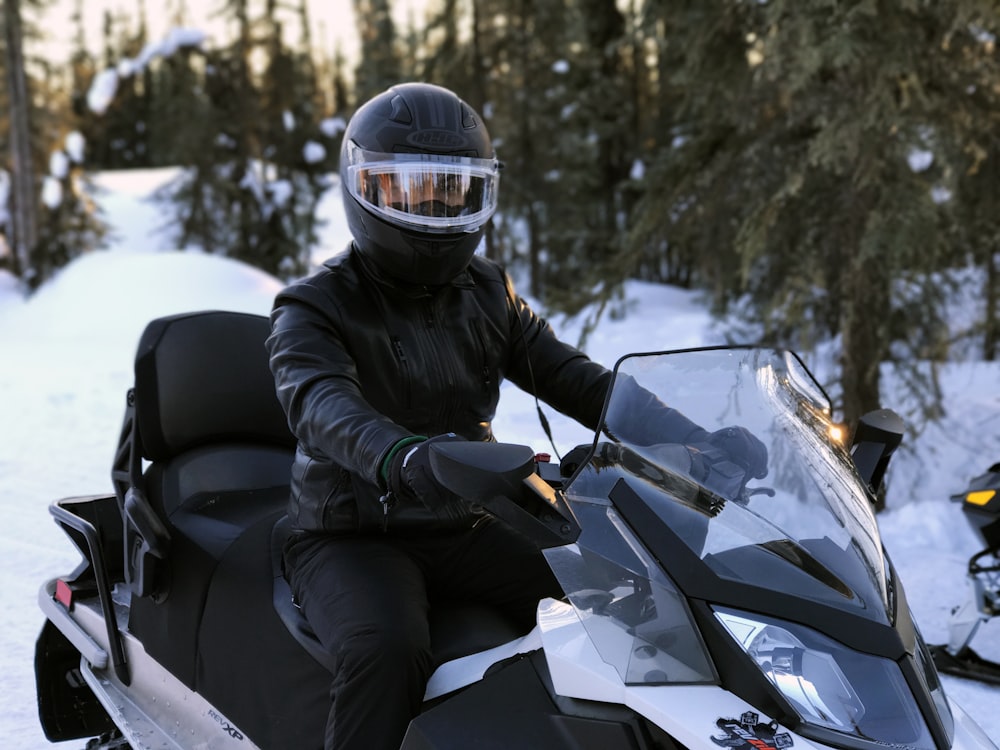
top-left (35, 311), bottom-right (995, 750)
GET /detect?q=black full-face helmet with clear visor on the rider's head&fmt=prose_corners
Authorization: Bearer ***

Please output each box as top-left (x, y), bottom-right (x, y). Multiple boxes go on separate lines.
top-left (340, 83), bottom-right (500, 285)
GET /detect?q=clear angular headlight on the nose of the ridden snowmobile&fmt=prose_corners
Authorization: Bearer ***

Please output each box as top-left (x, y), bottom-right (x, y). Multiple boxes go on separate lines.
top-left (714, 607), bottom-right (935, 750)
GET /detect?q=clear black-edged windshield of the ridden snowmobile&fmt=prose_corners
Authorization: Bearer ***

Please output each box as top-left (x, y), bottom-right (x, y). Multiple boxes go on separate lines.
top-left (567, 349), bottom-right (891, 624)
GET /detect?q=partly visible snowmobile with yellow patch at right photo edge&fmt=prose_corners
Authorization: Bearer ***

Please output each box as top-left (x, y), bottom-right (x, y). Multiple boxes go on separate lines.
top-left (931, 462), bottom-right (1000, 685)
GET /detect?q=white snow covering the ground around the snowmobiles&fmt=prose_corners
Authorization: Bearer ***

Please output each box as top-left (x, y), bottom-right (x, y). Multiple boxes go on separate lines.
top-left (0, 170), bottom-right (1000, 748)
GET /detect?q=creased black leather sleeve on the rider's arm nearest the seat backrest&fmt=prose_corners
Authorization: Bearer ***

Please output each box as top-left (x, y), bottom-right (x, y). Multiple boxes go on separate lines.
top-left (267, 284), bottom-right (411, 484)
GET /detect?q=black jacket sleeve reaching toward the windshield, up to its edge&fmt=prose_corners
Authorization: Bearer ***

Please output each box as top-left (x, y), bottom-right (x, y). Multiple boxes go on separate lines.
top-left (506, 276), bottom-right (611, 430)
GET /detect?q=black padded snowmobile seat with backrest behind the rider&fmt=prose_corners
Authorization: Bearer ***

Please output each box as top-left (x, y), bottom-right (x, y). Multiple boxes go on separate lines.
top-left (121, 311), bottom-right (295, 688)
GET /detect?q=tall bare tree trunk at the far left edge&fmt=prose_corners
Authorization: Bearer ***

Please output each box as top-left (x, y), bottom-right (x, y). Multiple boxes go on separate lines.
top-left (3, 0), bottom-right (38, 283)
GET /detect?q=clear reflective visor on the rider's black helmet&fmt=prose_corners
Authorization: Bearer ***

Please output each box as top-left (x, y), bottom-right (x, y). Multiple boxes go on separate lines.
top-left (345, 149), bottom-right (500, 233)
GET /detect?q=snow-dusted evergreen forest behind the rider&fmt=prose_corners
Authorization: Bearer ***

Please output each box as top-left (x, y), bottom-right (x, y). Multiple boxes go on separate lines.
top-left (0, 0), bottom-right (1000, 444)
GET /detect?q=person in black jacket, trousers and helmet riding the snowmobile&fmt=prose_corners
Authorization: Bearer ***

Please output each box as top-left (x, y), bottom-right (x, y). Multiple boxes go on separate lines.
top-left (267, 83), bottom-right (766, 750)
